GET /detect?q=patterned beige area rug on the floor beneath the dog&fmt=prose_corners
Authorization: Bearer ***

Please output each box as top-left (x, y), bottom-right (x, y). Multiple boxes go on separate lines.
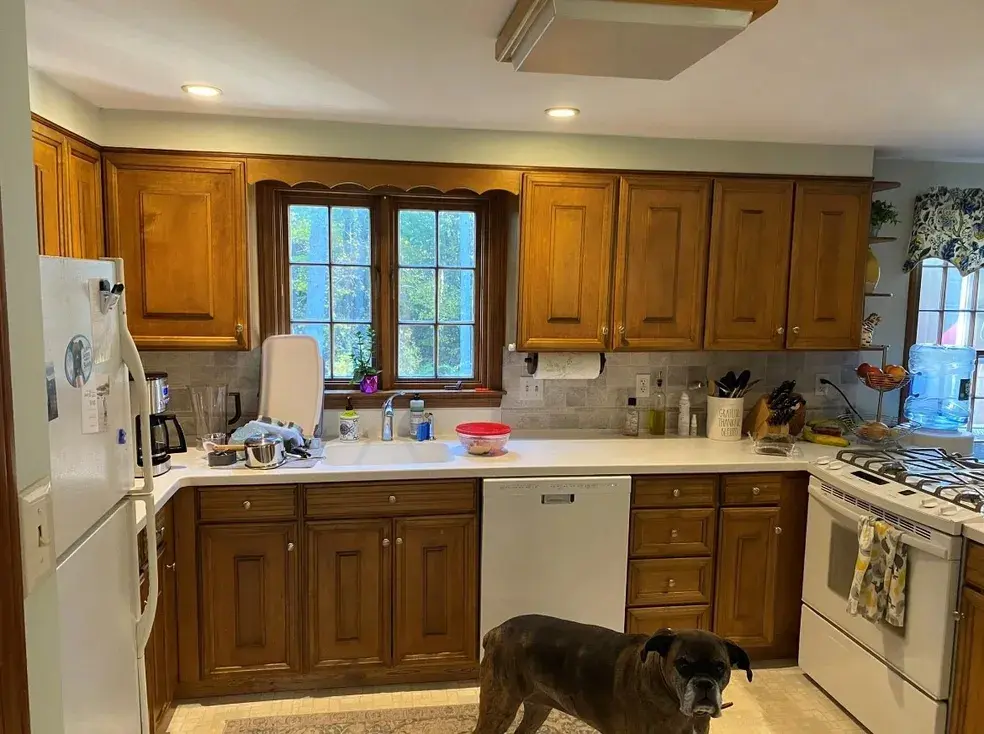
top-left (223, 704), bottom-right (597, 734)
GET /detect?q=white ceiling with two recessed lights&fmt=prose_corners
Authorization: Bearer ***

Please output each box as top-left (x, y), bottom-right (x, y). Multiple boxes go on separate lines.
top-left (26, 0), bottom-right (984, 156)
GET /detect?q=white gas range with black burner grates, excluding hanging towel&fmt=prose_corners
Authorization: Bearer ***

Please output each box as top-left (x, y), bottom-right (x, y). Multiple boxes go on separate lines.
top-left (799, 448), bottom-right (984, 734)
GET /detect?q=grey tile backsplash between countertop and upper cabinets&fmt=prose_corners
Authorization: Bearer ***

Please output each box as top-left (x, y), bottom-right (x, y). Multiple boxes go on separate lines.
top-left (141, 349), bottom-right (862, 436)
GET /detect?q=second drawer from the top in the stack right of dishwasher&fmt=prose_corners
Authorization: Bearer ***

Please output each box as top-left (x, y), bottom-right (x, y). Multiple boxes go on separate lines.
top-left (629, 508), bottom-right (716, 558)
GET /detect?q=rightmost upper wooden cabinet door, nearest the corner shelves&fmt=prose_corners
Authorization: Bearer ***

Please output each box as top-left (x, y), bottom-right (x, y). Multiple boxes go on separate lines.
top-left (786, 182), bottom-right (871, 349)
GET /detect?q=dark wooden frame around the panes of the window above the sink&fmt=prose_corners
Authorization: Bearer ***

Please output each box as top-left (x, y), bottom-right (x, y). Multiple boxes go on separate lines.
top-left (256, 182), bottom-right (508, 408)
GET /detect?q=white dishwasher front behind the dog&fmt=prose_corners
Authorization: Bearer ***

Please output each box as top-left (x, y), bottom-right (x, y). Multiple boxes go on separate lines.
top-left (481, 477), bottom-right (632, 637)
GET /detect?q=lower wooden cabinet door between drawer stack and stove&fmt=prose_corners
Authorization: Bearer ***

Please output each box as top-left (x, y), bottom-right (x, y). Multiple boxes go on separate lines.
top-left (714, 507), bottom-right (779, 648)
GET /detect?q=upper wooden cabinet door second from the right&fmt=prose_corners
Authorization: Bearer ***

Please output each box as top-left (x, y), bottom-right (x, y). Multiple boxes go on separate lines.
top-left (704, 179), bottom-right (793, 350)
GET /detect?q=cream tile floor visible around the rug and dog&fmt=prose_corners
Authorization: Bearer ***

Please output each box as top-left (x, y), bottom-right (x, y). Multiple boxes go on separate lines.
top-left (168, 667), bottom-right (865, 734)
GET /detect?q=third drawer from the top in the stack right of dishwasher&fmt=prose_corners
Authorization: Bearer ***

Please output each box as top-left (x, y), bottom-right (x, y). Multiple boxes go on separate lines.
top-left (628, 558), bottom-right (713, 607)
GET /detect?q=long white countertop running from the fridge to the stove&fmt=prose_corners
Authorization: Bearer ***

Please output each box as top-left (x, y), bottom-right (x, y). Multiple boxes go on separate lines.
top-left (137, 438), bottom-right (838, 528)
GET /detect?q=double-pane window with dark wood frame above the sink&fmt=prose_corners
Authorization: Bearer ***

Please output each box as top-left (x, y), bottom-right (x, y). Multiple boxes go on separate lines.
top-left (257, 184), bottom-right (505, 403)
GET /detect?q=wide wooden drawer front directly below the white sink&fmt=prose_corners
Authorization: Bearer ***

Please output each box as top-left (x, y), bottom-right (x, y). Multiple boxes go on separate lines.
top-left (304, 480), bottom-right (477, 518)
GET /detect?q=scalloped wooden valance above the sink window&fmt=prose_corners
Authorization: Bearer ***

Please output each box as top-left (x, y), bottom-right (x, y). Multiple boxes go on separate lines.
top-left (246, 157), bottom-right (523, 195)
